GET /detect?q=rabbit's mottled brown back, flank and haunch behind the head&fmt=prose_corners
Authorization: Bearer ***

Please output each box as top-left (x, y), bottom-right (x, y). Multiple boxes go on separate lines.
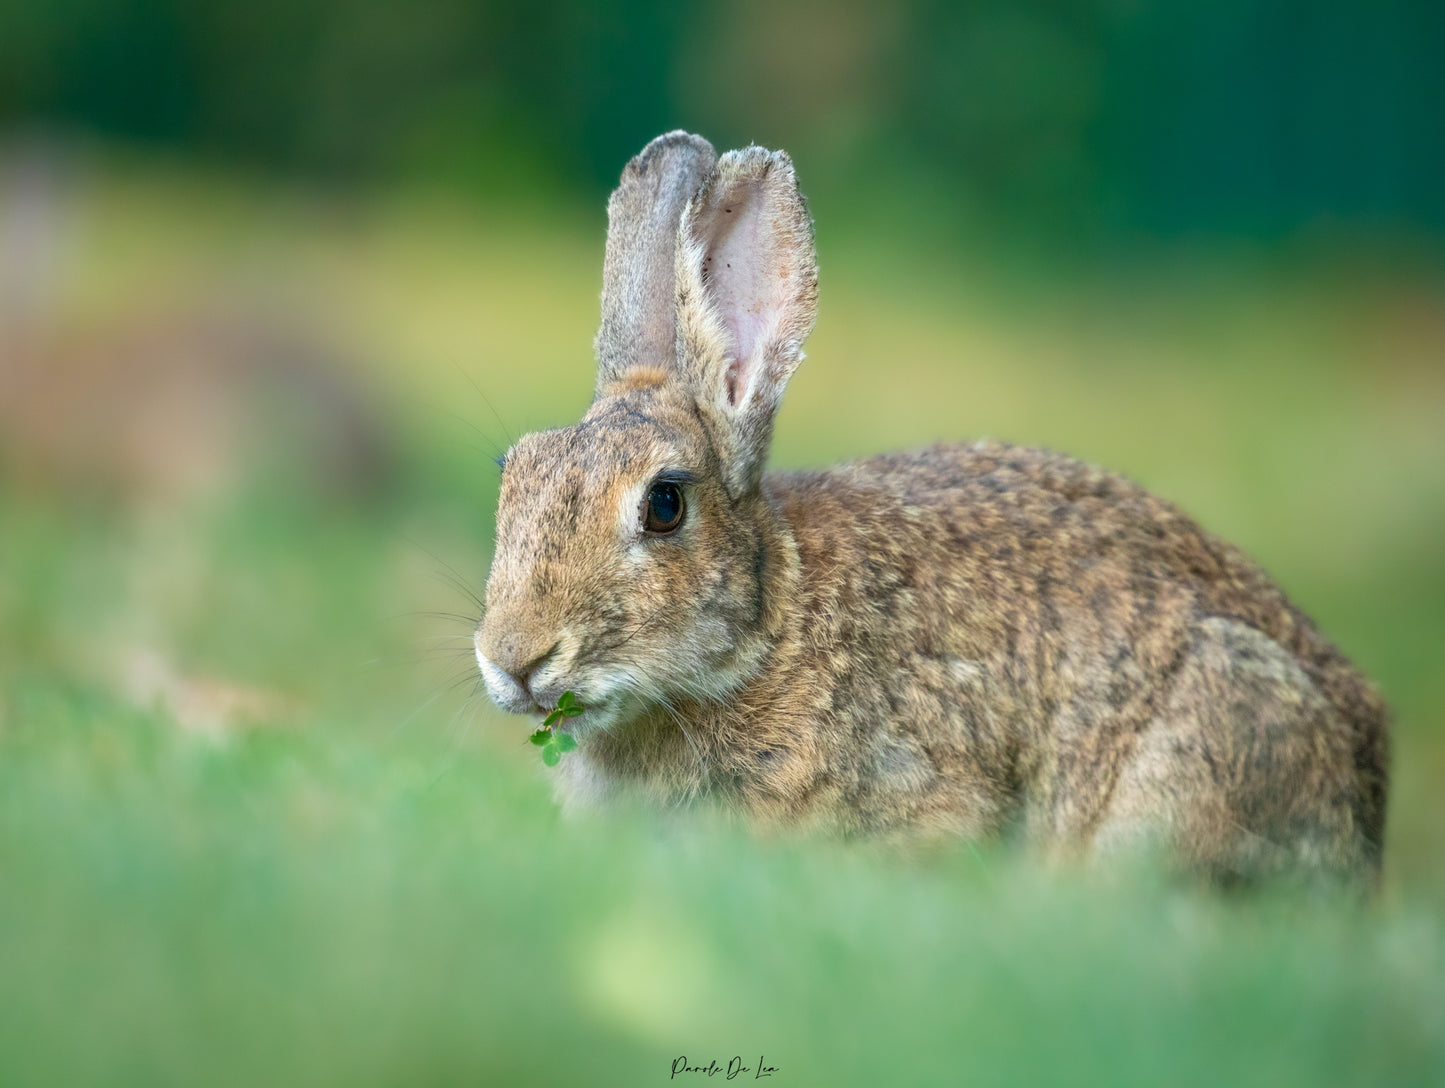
top-left (767, 444), bottom-right (1386, 868)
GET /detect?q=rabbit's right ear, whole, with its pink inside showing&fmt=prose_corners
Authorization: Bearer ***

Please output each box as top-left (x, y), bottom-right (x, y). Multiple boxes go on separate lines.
top-left (678, 147), bottom-right (818, 498)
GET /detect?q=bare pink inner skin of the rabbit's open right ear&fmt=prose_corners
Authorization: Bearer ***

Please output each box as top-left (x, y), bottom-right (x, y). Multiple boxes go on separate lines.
top-left (707, 185), bottom-right (782, 407)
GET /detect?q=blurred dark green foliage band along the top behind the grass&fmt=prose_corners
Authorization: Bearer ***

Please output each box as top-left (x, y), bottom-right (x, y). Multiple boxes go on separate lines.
top-left (0, 0), bottom-right (1445, 249)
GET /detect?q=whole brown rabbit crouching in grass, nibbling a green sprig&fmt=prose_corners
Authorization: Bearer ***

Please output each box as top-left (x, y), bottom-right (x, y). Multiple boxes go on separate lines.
top-left (474, 131), bottom-right (1387, 886)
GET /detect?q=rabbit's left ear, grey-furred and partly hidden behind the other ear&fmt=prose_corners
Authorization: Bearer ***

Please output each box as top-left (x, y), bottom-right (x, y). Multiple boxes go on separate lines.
top-left (595, 130), bottom-right (717, 393)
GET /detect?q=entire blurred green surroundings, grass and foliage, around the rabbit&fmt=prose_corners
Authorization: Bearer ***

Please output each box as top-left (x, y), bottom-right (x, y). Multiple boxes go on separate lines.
top-left (0, 0), bottom-right (1445, 1085)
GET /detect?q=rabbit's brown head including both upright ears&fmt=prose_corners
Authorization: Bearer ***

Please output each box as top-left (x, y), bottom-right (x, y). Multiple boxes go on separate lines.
top-left (475, 131), bottom-right (816, 727)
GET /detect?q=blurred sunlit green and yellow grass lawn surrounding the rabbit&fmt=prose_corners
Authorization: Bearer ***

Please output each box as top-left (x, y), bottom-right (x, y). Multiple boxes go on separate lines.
top-left (0, 156), bottom-right (1445, 1085)
